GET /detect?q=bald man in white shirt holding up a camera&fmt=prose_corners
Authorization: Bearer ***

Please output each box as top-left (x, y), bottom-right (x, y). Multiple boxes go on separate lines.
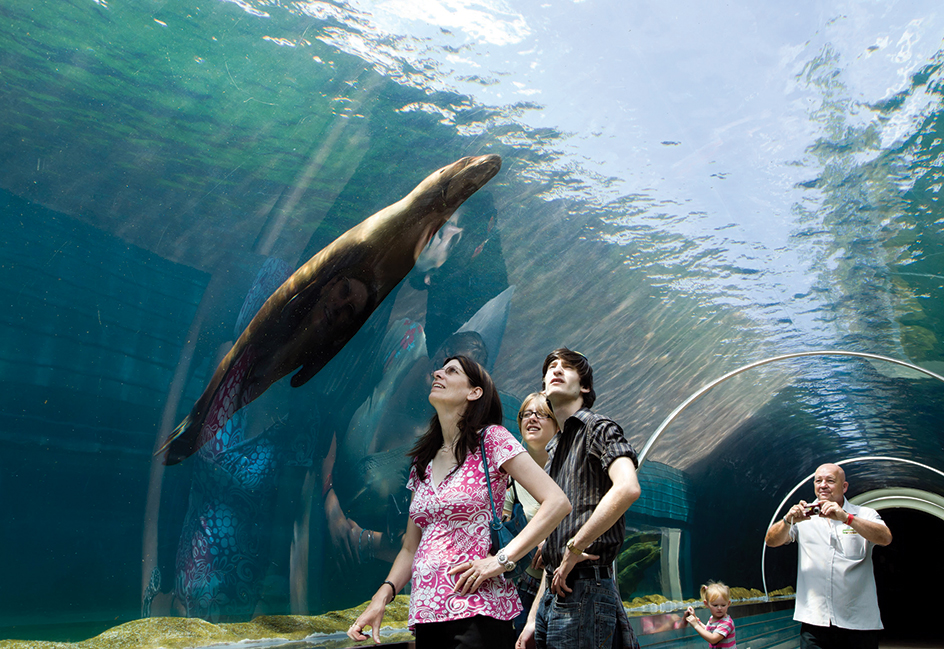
top-left (765, 464), bottom-right (892, 649)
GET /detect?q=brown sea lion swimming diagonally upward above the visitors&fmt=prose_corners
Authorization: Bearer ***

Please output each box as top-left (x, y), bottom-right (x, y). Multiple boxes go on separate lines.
top-left (156, 155), bottom-right (501, 465)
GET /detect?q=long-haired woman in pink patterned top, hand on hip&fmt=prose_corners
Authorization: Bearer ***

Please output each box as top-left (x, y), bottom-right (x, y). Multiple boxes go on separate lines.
top-left (347, 356), bottom-right (571, 649)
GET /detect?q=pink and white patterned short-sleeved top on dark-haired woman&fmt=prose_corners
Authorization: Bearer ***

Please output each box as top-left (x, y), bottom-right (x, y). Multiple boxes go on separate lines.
top-left (406, 426), bottom-right (525, 629)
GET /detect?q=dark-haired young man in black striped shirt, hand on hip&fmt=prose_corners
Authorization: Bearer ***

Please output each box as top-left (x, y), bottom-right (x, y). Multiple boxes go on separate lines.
top-left (517, 348), bottom-right (640, 649)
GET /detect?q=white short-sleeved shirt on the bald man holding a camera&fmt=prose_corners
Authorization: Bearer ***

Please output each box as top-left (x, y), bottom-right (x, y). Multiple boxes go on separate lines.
top-left (790, 500), bottom-right (885, 630)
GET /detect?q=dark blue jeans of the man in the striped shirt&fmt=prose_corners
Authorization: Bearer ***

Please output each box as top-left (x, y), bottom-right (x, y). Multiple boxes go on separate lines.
top-left (534, 578), bottom-right (639, 649)
